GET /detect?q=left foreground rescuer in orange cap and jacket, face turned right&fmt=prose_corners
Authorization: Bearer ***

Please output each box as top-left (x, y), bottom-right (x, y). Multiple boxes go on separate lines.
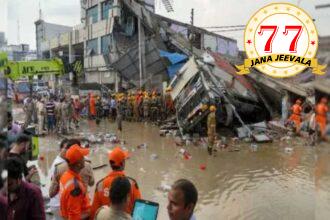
top-left (60, 144), bottom-right (90, 220)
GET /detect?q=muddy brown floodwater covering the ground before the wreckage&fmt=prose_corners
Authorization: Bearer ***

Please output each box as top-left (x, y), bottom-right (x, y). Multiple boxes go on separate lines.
top-left (28, 117), bottom-right (330, 220)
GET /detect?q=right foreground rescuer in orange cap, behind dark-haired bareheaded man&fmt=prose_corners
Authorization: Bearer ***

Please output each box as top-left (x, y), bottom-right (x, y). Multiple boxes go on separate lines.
top-left (92, 147), bottom-right (141, 217)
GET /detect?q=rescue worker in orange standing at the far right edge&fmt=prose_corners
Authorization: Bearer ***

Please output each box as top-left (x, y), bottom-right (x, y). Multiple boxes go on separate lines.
top-left (315, 97), bottom-right (329, 140)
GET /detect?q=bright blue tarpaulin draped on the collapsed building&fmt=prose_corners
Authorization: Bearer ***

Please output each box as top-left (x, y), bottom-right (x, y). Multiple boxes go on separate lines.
top-left (159, 50), bottom-right (188, 79)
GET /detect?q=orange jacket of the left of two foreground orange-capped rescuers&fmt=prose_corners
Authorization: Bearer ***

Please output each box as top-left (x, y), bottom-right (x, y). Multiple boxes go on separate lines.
top-left (60, 170), bottom-right (90, 220)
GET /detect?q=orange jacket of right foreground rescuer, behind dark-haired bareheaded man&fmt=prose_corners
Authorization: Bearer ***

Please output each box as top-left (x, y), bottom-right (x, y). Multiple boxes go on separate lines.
top-left (91, 171), bottom-right (141, 219)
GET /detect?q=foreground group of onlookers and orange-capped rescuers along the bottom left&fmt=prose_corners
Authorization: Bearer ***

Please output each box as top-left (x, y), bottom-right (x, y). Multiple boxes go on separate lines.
top-left (0, 131), bottom-right (198, 220)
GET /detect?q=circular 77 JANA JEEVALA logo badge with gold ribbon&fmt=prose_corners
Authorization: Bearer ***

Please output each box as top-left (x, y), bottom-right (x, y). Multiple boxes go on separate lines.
top-left (244, 3), bottom-right (318, 78)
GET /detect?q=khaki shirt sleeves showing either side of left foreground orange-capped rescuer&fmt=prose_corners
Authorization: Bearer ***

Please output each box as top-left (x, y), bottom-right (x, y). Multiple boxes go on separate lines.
top-left (49, 160), bottom-right (95, 197)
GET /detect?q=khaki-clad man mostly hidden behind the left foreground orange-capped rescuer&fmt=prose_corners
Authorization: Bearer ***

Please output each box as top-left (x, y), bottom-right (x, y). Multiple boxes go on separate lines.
top-left (49, 139), bottom-right (95, 198)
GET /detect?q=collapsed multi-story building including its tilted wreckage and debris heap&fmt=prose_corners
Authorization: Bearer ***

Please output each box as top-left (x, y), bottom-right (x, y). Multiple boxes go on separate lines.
top-left (37, 0), bottom-right (327, 135)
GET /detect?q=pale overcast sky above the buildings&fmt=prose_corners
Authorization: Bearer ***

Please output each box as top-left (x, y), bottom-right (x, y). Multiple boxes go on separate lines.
top-left (0, 0), bottom-right (330, 49)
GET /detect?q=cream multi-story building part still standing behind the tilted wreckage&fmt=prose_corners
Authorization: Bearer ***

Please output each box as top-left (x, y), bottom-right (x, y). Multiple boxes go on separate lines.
top-left (37, 0), bottom-right (238, 88)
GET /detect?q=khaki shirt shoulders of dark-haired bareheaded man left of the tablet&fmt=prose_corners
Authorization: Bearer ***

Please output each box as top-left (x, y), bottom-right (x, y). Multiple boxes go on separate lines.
top-left (95, 206), bottom-right (132, 220)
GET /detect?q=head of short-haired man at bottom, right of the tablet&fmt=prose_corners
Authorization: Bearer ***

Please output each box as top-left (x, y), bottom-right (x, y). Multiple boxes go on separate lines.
top-left (167, 179), bottom-right (198, 220)
